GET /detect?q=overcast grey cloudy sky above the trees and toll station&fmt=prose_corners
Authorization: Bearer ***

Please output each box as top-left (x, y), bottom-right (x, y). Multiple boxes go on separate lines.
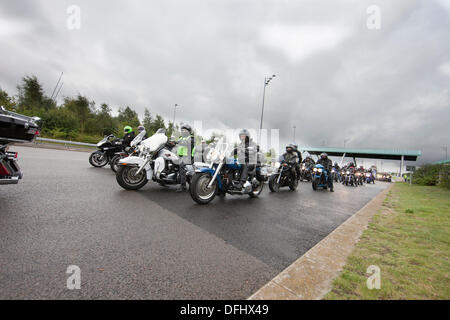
top-left (0, 0), bottom-right (450, 168)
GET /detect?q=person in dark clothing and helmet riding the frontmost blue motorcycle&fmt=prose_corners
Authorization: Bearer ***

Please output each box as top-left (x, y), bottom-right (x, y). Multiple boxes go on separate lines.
top-left (233, 129), bottom-right (257, 189)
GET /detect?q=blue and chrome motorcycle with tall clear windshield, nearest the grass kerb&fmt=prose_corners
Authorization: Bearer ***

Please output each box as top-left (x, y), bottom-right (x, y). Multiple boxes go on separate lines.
top-left (189, 138), bottom-right (267, 204)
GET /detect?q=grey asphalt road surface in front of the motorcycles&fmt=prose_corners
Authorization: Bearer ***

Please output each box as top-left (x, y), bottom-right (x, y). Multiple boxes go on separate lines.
top-left (0, 146), bottom-right (387, 299)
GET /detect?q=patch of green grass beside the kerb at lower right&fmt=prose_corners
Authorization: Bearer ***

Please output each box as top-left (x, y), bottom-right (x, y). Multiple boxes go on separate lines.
top-left (325, 183), bottom-right (450, 299)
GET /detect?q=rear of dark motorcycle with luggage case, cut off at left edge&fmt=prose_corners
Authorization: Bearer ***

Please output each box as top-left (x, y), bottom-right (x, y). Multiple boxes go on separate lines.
top-left (0, 106), bottom-right (41, 185)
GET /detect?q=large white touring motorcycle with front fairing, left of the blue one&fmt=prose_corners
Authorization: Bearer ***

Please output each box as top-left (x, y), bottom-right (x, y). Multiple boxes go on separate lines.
top-left (116, 129), bottom-right (206, 190)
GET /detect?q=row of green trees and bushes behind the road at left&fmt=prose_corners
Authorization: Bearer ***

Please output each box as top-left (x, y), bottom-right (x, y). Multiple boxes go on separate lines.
top-left (0, 76), bottom-right (178, 143)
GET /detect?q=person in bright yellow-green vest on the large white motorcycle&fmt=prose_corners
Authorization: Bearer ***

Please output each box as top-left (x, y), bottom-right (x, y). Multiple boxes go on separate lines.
top-left (177, 124), bottom-right (195, 192)
